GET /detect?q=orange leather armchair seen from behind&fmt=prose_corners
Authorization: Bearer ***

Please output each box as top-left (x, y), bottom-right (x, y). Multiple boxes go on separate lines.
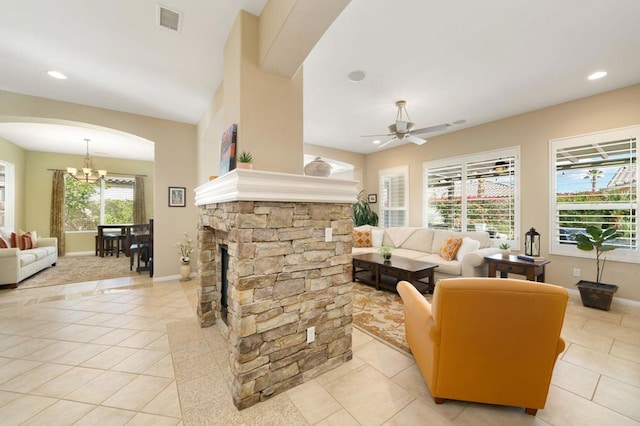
top-left (397, 278), bottom-right (569, 416)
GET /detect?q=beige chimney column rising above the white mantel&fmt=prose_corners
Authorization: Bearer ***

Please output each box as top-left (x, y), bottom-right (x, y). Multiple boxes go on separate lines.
top-left (224, 11), bottom-right (303, 173)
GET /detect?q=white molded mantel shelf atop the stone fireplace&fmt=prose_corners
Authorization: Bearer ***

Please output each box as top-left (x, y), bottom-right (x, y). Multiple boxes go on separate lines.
top-left (195, 169), bottom-right (358, 206)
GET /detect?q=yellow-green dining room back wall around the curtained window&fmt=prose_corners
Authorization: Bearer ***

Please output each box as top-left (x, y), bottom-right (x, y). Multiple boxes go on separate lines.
top-left (25, 151), bottom-right (154, 253)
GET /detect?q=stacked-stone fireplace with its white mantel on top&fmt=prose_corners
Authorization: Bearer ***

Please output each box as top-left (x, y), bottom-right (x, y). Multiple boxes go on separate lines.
top-left (196, 169), bottom-right (357, 409)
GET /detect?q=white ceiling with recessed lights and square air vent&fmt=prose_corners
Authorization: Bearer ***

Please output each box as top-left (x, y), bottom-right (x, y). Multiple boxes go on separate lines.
top-left (0, 0), bottom-right (640, 159)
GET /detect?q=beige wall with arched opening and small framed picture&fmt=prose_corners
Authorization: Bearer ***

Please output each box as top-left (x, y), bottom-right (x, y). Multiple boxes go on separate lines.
top-left (0, 91), bottom-right (197, 277)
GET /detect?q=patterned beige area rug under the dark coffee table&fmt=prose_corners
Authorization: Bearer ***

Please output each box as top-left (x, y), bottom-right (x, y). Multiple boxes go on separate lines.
top-left (353, 282), bottom-right (431, 353)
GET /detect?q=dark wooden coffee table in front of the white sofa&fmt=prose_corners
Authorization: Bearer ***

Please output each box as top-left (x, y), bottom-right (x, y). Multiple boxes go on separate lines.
top-left (352, 253), bottom-right (438, 293)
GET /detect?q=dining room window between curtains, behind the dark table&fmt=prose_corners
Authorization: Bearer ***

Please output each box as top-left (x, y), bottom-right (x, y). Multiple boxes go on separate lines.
top-left (64, 176), bottom-right (134, 232)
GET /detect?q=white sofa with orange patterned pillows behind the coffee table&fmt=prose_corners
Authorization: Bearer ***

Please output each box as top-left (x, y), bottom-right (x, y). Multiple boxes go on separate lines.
top-left (352, 225), bottom-right (500, 281)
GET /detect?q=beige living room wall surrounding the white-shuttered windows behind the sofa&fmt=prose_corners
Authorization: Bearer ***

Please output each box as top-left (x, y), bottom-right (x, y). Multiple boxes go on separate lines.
top-left (365, 85), bottom-right (640, 300)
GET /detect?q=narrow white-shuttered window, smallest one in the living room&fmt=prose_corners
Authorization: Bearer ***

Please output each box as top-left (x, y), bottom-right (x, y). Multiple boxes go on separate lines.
top-left (378, 166), bottom-right (409, 228)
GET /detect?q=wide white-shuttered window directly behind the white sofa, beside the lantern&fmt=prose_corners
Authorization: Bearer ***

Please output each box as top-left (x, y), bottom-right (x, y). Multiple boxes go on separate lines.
top-left (423, 148), bottom-right (520, 247)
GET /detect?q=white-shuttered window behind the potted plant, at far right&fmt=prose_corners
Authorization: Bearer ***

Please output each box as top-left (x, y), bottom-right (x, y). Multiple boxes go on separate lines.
top-left (549, 126), bottom-right (640, 261)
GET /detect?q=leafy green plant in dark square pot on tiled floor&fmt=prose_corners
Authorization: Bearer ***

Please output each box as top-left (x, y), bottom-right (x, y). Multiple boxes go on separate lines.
top-left (575, 226), bottom-right (622, 311)
